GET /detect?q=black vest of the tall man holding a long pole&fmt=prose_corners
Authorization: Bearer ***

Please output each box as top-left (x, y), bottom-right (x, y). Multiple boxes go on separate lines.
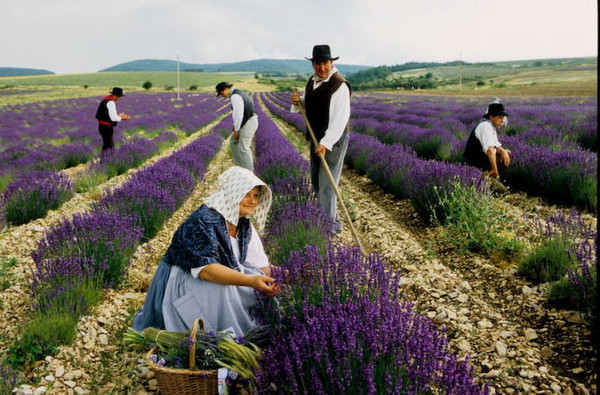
top-left (304, 73), bottom-right (352, 141)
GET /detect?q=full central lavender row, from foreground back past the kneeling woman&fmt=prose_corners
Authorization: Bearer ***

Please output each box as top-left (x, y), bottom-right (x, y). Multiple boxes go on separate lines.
top-left (251, 98), bottom-right (487, 394)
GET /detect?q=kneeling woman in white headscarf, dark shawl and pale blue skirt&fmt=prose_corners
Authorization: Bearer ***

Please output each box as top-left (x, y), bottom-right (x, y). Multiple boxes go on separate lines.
top-left (133, 166), bottom-right (275, 336)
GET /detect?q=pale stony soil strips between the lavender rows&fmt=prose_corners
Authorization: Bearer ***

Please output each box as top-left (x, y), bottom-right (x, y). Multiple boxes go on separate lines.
top-left (0, 103), bottom-right (597, 394)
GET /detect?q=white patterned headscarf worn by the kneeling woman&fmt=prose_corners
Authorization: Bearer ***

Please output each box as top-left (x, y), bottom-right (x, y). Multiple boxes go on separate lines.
top-left (204, 166), bottom-right (272, 232)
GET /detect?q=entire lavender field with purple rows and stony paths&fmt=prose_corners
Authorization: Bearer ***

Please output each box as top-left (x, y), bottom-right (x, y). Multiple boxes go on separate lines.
top-left (0, 84), bottom-right (597, 394)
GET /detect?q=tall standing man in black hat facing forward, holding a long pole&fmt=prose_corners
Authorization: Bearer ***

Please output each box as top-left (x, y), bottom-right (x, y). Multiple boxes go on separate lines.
top-left (291, 45), bottom-right (351, 234)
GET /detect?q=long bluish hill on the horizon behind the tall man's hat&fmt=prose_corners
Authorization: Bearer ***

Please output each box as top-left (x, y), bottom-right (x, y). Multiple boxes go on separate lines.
top-left (100, 59), bottom-right (372, 75)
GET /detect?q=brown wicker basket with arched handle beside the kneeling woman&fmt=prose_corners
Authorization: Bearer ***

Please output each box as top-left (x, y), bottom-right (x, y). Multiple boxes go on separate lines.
top-left (146, 318), bottom-right (218, 395)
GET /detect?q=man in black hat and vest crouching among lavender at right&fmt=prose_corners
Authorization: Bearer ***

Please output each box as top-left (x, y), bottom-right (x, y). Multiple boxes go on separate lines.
top-left (463, 99), bottom-right (510, 193)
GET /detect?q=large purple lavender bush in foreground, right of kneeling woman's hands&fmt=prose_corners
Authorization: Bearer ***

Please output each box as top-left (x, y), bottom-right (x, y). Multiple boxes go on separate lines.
top-left (257, 247), bottom-right (486, 394)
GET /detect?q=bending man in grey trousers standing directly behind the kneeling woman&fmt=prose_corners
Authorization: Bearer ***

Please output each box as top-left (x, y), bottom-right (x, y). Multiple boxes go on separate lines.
top-left (215, 82), bottom-right (258, 171)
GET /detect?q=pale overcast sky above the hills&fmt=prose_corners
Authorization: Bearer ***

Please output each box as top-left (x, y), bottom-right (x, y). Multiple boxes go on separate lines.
top-left (0, 0), bottom-right (598, 74)
